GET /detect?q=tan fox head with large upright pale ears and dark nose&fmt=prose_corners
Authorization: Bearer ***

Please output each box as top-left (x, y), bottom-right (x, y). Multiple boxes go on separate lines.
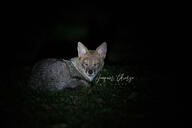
top-left (77, 42), bottom-right (107, 81)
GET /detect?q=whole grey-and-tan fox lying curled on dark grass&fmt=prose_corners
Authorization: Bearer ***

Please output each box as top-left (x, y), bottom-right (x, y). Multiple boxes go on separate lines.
top-left (29, 42), bottom-right (107, 91)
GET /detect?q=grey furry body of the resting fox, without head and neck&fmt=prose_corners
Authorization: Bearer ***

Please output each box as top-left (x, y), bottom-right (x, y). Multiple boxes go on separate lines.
top-left (29, 59), bottom-right (90, 91)
